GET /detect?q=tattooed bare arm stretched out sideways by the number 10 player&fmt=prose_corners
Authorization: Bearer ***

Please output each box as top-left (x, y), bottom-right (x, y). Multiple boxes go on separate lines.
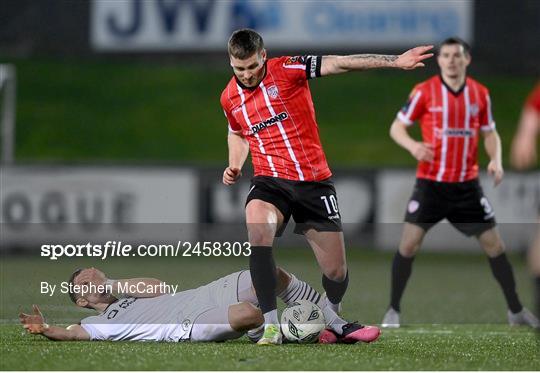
top-left (321, 45), bottom-right (433, 76)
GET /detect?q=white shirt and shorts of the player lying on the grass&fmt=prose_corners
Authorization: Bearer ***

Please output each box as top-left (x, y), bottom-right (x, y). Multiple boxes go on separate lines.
top-left (81, 272), bottom-right (240, 342)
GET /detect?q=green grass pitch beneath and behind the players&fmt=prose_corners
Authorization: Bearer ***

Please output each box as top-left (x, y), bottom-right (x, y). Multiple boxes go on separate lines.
top-left (0, 249), bottom-right (540, 370)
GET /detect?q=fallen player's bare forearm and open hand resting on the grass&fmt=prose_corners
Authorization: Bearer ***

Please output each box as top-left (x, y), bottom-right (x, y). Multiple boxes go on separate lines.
top-left (19, 304), bottom-right (90, 341)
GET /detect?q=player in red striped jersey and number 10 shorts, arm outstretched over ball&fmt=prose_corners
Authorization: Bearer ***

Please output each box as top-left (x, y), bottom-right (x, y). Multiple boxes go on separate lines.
top-left (221, 29), bottom-right (432, 344)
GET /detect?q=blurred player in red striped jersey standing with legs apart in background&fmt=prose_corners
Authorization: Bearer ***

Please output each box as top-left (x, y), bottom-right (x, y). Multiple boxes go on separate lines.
top-left (382, 38), bottom-right (538, 327)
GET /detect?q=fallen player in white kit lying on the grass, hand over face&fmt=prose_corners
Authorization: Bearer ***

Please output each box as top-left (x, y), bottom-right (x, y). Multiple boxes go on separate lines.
top-left (19, 268), bottom-right (380, 343)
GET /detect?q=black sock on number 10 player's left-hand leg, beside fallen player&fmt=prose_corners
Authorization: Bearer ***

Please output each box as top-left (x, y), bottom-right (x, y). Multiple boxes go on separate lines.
top-left (249, 246), bottom-right (277, 314)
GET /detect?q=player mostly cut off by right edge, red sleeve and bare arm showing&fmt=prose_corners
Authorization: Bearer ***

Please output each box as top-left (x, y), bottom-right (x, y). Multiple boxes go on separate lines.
top-left (510, 82), bottom-right (540, 322)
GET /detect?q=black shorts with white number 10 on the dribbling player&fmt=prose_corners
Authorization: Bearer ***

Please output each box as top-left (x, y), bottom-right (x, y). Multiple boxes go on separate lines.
top-left (246, 176), bottom-right (343, 236)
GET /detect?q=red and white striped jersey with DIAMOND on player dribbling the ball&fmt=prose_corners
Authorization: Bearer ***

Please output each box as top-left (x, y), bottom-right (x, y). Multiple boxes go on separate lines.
top-left (221, 56), bottom-right (332, 181)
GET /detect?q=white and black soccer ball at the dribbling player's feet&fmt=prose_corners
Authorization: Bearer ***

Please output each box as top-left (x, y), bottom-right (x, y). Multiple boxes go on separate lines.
top-left (281, 300), bottom-right (326, 343)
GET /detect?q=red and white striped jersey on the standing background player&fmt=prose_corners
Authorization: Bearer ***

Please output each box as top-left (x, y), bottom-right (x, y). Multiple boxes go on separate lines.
top-left (397, 75), bottom-right (495, 182)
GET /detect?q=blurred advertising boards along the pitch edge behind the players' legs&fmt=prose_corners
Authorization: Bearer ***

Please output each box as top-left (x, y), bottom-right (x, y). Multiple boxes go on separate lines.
top-left (0, 166), bottom-right (540, 252)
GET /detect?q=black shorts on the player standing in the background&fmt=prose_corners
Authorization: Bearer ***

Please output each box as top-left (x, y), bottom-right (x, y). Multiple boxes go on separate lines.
top-left (405, 179), bottom-right (496, 236)
